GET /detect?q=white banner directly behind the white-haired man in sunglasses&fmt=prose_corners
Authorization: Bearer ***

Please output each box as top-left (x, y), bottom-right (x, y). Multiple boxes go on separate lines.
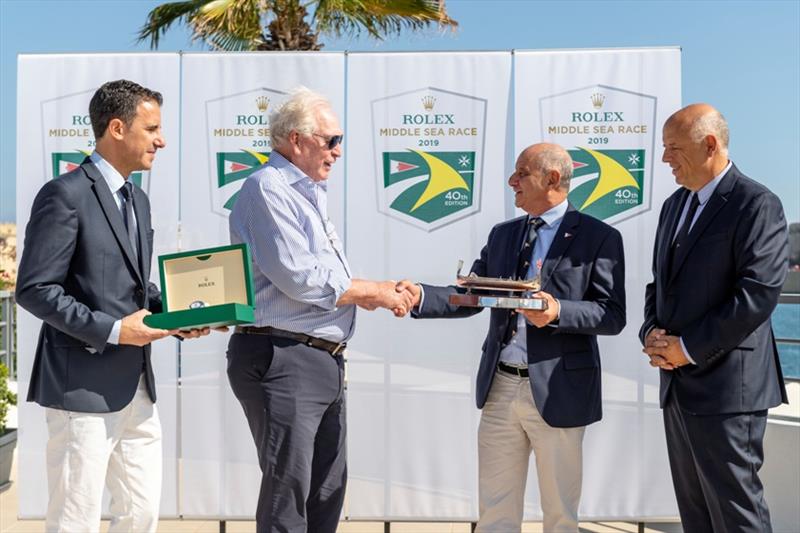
top-left (179, 53), bottom-right (344, 518)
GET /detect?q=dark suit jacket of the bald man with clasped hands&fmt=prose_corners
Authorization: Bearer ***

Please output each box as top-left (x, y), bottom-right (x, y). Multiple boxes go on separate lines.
top-left (639, 166), bottom-right (788, 414)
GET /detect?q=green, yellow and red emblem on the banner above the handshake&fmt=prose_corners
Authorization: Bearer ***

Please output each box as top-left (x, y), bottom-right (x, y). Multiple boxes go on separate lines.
top-left (383, 149), bottom-right (475, 223)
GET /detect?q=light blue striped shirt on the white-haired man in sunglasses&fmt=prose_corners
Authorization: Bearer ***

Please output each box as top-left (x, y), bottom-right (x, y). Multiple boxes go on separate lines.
top-left (229, 151), bottom-right (356, 342)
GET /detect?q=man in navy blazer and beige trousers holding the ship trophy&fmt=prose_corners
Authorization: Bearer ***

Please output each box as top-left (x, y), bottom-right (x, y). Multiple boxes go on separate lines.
top-left (398, 144), bottom-right (625, 533)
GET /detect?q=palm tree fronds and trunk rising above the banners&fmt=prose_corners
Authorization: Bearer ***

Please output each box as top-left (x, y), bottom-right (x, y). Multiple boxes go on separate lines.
top-left (138, 0), bottom-right (458, 50)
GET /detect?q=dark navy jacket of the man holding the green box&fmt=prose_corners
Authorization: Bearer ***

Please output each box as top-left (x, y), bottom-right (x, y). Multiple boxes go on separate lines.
top-left (16, 158), bottom-right (161, 413)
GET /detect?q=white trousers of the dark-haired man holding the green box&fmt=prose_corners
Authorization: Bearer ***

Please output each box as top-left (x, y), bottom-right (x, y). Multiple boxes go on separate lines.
top-left (45, 377), bottom-right (161, 533)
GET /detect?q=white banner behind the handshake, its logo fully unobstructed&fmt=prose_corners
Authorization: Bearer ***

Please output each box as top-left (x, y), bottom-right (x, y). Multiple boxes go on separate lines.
top-left (345, 52), bottom-right (511, 520)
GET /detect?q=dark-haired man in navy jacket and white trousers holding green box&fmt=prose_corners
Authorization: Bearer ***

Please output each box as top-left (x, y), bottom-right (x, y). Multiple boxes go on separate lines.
top-left (16, 80), bottom-right (208, 533)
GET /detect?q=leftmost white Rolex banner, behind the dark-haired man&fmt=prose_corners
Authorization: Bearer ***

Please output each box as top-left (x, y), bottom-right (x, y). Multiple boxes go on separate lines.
top-left (17, 54), bottom-right (180, 518)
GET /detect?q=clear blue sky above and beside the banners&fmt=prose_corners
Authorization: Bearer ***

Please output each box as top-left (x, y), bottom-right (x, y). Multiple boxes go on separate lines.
top-left (0, 0), bottom-right (800, 221)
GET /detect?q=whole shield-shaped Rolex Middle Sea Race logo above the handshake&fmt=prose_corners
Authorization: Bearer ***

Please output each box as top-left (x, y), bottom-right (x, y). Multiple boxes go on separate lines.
top-left (372, 87), bottom-right (486, 231)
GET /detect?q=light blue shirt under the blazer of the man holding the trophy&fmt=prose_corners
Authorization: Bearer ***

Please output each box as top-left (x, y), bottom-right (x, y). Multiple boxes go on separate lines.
top-left (500, 200), bottom-right (568, 367)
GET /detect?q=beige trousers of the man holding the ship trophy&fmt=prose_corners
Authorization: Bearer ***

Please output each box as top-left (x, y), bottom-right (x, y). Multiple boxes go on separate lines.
top-left (476, 370), bottom-right (586, 533)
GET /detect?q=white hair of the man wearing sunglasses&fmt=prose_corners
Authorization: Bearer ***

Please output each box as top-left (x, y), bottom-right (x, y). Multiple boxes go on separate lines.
top-left (269, 86), bottom-right (331, 148)
